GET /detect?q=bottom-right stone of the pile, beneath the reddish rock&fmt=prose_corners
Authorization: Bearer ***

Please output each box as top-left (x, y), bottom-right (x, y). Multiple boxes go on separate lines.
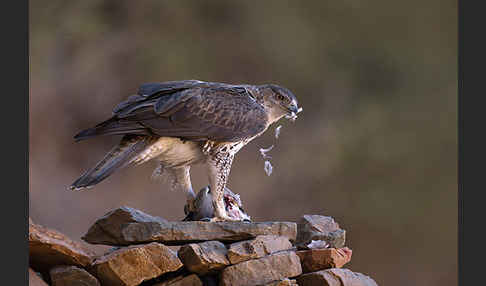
top-left (297, 268), bottom-right (378, 286)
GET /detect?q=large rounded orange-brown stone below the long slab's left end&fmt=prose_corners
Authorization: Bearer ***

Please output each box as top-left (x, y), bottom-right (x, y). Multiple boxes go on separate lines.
top-left (92, 242), bottom-right (182, 286)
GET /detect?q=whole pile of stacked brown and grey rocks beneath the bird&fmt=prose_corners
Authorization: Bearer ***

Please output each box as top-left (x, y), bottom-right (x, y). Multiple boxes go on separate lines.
top-left (29, 207), bottom-right (377, 286)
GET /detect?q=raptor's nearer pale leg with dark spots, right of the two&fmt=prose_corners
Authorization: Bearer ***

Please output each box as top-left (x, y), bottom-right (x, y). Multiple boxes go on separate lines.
top-left (207, 151), bottom-right (236, 221)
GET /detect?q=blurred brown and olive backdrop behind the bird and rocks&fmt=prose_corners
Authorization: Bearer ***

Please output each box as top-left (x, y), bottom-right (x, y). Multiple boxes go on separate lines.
top-left (29, 0), bottom-right (457, 286)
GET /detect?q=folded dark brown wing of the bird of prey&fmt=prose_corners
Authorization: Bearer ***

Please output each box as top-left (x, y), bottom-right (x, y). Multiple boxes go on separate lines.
top-left (77, 81), bottom-right (267, 142)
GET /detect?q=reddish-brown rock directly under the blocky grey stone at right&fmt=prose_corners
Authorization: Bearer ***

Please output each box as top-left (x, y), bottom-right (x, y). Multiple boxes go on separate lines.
top-left (297, 247), bottom-right (353, 273)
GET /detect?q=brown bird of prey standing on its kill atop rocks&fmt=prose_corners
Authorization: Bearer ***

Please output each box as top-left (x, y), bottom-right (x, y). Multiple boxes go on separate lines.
top-left (70, 80), bottom-right (302, 221)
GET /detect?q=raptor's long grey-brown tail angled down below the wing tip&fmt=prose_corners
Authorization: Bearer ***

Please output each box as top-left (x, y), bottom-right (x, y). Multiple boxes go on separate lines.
top-left (69, 135), bottom-right (152, 191)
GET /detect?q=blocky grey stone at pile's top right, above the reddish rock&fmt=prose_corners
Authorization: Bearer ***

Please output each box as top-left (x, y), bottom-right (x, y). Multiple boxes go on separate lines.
top-left (296, 215), bottom-right (346, 249)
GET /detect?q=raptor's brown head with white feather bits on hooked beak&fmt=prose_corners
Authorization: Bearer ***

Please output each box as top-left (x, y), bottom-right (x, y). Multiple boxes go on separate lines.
top-left (258, 84), bottom-right (302, 123)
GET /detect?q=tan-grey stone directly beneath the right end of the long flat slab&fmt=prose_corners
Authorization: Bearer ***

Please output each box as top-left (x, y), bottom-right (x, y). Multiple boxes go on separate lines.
top-left (228, 235), bottom-right (292, 264)
